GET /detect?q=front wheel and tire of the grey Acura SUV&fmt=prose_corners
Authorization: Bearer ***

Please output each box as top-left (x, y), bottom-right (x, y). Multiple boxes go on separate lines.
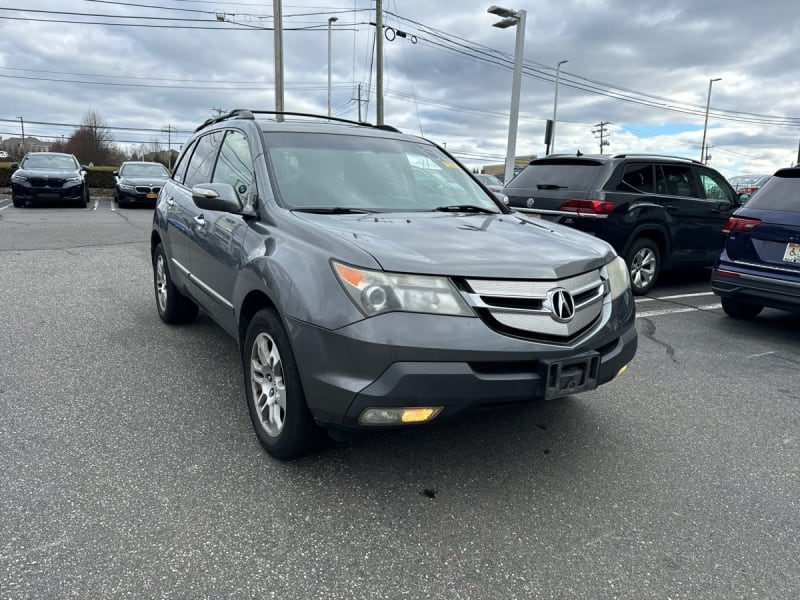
top-left (242, 309), bottom-right (322, 460)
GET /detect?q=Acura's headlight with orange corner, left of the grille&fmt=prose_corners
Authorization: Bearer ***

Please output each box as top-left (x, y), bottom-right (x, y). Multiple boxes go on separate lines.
top-left (333, 262), bottom-right (473, 317)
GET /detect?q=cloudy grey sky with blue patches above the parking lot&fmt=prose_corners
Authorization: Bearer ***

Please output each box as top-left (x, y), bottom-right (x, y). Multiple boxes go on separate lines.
top-left (0, 0), bottom-right (800, 176)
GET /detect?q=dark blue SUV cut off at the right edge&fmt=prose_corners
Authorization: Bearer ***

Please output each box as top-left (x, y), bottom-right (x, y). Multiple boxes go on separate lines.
top-left (711, 167), bottom-right (800, 319)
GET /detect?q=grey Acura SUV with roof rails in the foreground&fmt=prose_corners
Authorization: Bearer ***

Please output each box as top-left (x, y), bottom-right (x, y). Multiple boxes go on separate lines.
top-left (151, 110), bottom-right (637, 459)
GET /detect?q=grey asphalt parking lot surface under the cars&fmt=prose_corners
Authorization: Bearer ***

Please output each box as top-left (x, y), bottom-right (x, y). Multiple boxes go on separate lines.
top-left (0, 195), bottom-right (800, 600)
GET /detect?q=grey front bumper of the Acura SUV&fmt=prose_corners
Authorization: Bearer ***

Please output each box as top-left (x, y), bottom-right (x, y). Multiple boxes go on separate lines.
top-left (287, 299), bottom-right (637, 428)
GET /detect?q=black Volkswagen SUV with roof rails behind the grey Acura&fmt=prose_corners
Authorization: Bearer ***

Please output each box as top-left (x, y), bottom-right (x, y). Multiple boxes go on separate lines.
top-left (503, 154), bottom-right (742, 294)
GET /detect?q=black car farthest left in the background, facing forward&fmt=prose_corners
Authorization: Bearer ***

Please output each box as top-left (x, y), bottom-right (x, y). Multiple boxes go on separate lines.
top-left (11, 152), bottom-right (90, 208)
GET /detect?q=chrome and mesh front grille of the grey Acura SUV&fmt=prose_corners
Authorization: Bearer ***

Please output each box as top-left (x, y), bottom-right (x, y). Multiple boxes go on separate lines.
top-left (463, 270), bottom-right (606, 343)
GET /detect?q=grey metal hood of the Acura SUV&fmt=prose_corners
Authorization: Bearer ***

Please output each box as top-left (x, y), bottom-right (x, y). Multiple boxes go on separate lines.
top-left (295, 212), bottom-right (614, 279)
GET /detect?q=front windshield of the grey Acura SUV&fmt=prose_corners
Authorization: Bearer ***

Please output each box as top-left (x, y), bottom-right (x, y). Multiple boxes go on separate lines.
top-left (265, 132), bottom-right (501, 212)
